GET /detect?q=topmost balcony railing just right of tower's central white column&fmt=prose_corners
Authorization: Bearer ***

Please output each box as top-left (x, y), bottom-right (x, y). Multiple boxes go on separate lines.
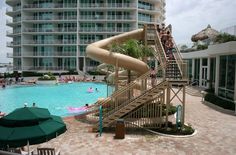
top-left (79, 3), bottom-right (136, 8)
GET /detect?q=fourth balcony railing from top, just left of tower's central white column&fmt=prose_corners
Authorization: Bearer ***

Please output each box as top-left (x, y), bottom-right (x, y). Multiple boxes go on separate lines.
top-left (23, 40), bottom-right (76, 44)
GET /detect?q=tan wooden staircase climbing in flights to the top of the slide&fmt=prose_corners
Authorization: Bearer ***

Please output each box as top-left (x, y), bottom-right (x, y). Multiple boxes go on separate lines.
top-left (91, 25), bottom-right (187, 130)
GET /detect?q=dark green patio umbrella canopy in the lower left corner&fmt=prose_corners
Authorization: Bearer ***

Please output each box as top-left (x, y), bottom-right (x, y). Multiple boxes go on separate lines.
top-left (0, 108), bottom-right (66, 148)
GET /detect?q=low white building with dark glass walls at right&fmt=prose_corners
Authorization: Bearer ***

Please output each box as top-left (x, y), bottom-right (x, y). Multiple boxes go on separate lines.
top-left (182, 41), bottom-right (236, 101)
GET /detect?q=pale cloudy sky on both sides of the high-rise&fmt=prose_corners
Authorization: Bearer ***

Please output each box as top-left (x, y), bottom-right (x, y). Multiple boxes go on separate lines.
top-left (0, 0), bottom-right (236, 63)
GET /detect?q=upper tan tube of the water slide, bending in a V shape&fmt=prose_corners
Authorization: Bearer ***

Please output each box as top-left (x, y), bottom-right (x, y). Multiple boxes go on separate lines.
top-left (86, 29), bottom-right (149, 75)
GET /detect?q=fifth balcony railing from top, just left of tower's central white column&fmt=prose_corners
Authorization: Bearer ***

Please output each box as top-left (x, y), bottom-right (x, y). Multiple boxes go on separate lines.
top-left (33, 51), bottom-right (76, 57)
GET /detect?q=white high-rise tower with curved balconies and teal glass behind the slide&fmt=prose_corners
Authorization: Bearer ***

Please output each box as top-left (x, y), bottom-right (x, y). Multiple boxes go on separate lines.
top-left (6, 0), bottom-right (165, 72)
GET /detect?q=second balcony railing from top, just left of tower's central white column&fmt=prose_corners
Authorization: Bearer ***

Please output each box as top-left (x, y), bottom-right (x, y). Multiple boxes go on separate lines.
top-left (24, 15), bottom-right (77, 20)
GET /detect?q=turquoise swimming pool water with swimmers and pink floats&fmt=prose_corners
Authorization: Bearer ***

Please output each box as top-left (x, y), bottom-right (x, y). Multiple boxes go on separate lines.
top-left (0, 82), bottom-right (110, 116)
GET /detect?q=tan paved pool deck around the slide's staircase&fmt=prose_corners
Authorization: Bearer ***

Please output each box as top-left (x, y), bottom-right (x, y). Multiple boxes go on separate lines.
top-left (31, 92), bottom-right (236, 155)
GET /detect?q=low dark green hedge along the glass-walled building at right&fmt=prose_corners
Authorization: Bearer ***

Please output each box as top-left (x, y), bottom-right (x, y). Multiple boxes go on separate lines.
top-left (205, 93), bottom-right (235, 111)
